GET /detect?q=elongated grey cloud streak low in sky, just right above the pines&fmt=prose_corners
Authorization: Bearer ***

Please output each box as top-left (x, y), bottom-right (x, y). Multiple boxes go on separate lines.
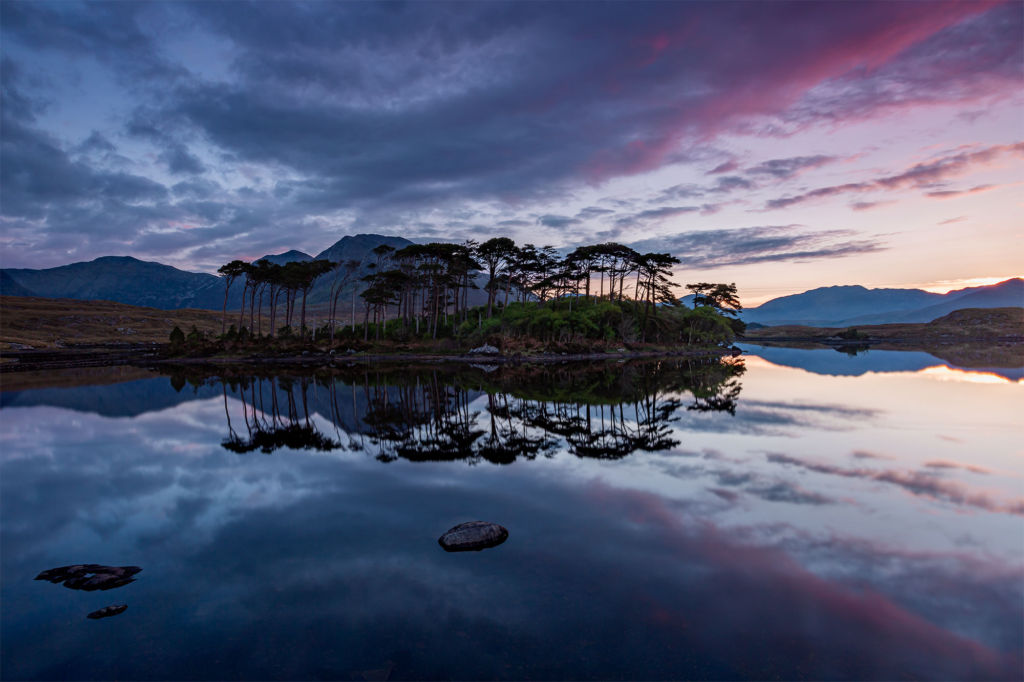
top-left (630, 225), bottom-right (885, 268)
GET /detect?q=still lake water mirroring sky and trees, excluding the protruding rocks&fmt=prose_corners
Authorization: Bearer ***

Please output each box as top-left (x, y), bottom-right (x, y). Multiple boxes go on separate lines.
top-left (0, 349), bottom-right (1024, 680)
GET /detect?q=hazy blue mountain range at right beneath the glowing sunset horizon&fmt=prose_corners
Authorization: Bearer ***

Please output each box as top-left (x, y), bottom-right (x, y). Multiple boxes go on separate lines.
top-left (742, 279), bottom-right (1024, 327)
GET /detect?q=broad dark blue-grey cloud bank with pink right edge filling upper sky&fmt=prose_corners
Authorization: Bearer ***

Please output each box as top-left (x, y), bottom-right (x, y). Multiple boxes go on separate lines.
top-left (0, 2), bottom-right (1020, 262)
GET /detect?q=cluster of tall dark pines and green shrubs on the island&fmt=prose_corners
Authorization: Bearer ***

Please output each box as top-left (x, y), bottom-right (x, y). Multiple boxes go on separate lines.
top-left (209, 237), bottom-right (742, 343)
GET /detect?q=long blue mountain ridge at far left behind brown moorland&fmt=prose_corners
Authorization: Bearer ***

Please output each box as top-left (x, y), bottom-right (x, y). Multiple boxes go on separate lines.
top-left (2, 256), bottom-right (241, 310)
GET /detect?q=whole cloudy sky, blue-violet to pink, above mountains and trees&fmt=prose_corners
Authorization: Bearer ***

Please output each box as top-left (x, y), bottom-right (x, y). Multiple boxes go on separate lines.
top-left (0, 1), bottom-right (1024, 305)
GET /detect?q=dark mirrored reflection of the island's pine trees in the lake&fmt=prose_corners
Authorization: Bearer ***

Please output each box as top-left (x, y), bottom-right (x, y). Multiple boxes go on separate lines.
top-left (189, 357), bottom-right (745, 464)
